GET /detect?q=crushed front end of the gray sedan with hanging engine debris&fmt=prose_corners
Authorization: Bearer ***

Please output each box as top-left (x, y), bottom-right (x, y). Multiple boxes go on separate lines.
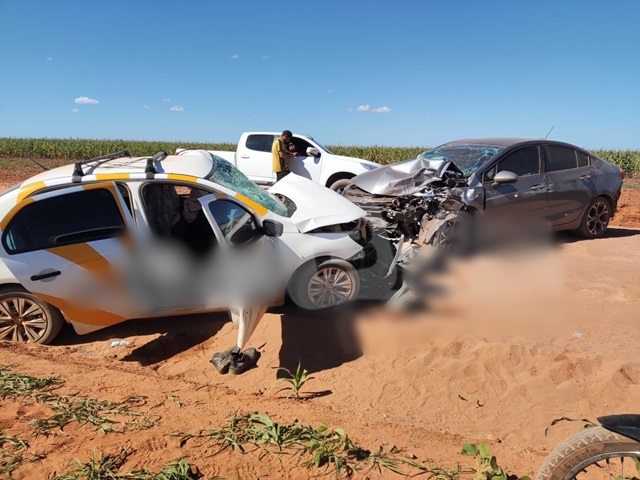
top-left (343, 158), bottom-right (473, 307)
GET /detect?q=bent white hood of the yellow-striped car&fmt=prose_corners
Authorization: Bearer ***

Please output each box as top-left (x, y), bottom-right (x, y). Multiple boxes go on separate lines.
top-left (269, 173), bottom-right (366, 233)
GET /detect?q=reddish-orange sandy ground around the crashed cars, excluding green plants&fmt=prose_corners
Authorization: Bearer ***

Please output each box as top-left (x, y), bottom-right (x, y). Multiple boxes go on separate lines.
top-left (0, 169), bottom-right (640, 479)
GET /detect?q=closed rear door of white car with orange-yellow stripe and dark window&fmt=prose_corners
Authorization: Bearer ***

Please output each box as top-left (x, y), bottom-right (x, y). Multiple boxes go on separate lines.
top-left (0, 182), bottom-right (137, 333)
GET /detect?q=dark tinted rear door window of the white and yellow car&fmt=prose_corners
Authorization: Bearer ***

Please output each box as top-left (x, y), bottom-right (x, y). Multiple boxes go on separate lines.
top-left (2, 188), bottom-right (125, 254)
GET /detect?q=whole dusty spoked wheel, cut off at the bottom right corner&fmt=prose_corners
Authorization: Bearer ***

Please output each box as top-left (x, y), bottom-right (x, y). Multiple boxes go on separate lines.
top-left (536, 427), bottom-right (640, 480)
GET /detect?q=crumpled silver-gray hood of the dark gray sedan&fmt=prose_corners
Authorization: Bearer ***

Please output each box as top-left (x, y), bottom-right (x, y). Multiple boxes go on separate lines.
top-left (351, 158), bottom-right (462, 196)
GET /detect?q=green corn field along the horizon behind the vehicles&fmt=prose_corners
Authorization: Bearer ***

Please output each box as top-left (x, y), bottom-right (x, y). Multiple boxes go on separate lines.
top-left (0, 138), bottom-right (640, 176)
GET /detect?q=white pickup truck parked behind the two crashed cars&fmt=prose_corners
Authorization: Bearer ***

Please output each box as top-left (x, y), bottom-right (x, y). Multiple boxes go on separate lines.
top-left (205, 132), bottom-right (380, 190)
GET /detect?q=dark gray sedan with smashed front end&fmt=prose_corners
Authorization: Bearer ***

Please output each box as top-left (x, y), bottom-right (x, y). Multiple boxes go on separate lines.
top-left (344, 138), bottom-right (624, 244)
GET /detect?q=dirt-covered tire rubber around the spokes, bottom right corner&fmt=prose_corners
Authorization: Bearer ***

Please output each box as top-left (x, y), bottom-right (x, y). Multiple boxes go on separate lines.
top-left (536, 427), bottom-right (640, 480)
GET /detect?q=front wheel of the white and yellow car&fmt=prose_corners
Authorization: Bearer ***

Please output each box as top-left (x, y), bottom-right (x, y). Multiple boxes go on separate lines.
top-left (288, 258), bottom-right (360, 310)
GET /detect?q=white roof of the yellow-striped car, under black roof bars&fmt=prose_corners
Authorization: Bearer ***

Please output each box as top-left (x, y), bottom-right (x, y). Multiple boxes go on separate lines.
top-left (22, 152), bottom-right (214, 186)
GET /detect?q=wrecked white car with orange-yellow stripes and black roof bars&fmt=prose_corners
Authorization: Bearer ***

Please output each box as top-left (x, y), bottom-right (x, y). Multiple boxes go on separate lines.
top-left (0, 150), bottom-right (365, 344)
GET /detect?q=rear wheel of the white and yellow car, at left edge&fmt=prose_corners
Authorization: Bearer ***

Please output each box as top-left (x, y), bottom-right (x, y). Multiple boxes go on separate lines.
top-left (0, 286), bottom-right (65, 345)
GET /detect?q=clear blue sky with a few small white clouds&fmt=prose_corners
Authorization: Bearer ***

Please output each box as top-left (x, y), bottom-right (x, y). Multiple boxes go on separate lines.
top-left (0, 0), bottom-right (640, 148)
